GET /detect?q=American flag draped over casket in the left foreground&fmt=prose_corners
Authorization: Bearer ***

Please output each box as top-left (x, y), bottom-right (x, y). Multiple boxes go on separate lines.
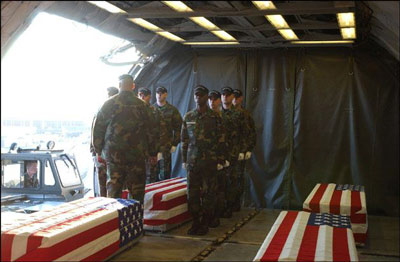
top-left (1, 197), bottom-right (143, 261)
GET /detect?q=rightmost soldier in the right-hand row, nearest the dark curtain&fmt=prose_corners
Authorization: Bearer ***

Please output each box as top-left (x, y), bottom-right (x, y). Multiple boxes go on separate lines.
top-left (233, 89), bottom-right (257, 211)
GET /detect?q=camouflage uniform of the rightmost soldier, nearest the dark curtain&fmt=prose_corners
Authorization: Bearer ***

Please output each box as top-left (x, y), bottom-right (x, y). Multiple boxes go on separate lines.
top-left (235, 107), bottom-right (257, 209)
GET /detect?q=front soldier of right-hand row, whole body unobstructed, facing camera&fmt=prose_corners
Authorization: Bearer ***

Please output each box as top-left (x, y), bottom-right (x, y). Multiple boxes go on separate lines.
top-left (181, 85), bottom-right (225, 235)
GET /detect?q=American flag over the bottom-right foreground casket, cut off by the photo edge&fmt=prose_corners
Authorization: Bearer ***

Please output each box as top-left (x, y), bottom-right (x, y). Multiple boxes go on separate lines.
top-left (254, 211), bottom-right (358, 261)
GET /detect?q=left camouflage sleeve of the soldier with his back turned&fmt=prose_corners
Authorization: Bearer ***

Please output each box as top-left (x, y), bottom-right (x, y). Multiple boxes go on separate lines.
top-left (91, 101), bottom-right (110, 155)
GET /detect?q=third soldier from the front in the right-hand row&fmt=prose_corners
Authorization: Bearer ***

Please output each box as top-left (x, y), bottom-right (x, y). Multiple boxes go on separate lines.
top-left (222, 87), bottom-right (246, 218)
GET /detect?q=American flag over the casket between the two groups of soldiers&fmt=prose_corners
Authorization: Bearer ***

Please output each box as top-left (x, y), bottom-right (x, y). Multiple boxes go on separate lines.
top-left (144, 177), bottom-right (191, 229)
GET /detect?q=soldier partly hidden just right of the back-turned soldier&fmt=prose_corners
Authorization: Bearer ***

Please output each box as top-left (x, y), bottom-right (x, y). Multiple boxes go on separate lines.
top-left (138, 87), bottom-right (161, 184)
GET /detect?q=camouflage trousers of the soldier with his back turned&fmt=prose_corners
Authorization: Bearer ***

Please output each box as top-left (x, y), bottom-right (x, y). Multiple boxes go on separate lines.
top-left (107, 161), bottom-right (146, 203)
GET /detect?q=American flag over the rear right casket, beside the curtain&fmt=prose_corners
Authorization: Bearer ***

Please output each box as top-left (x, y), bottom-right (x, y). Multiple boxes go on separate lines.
top-left (303, 183), bottom-right (368, 245)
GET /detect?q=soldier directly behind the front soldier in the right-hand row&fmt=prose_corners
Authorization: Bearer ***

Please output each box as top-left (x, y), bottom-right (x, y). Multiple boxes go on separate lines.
top-left (208, 90), bottom-right (230, 227)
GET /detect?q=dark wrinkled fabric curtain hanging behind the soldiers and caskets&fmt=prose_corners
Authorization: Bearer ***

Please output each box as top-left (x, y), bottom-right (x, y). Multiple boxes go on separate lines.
top-left (137, 47), bottom-right (399, 216)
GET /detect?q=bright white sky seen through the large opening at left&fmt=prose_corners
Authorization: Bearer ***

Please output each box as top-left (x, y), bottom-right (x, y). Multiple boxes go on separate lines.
top-left (1, 13), bottom-right (137, 124)
